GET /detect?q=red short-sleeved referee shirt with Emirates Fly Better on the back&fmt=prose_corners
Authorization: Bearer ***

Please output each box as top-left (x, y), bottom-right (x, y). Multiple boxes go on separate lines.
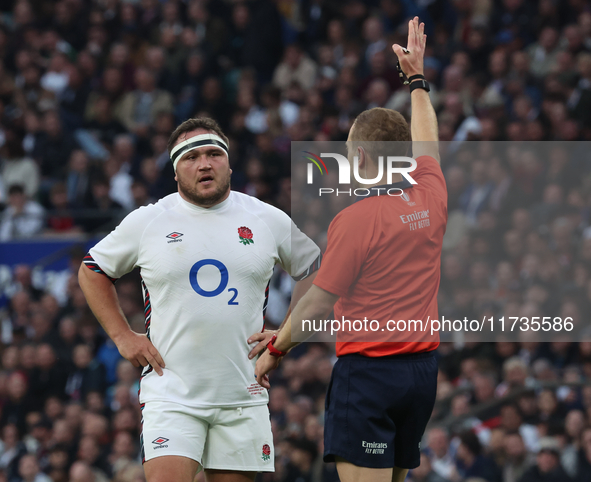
top-left (314, 156), bottom-right (447, 357)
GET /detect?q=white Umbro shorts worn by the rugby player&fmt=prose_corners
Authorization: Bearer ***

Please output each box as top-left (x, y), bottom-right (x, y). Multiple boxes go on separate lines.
top-left (140, 401), bottom-right (275, 472)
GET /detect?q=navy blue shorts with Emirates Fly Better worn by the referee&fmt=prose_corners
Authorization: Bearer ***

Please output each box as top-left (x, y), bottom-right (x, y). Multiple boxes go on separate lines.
top-left (324, 352), bottom-right (437, 469)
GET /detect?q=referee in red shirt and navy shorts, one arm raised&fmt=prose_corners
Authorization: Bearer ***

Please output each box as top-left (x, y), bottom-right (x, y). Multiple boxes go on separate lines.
top-left (249, 17), bottom-right (447, 482)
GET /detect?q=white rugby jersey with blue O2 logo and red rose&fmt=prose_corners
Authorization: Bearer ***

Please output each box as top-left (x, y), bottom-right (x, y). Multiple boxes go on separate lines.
top-left (85, 191), bottom-right (321, 407)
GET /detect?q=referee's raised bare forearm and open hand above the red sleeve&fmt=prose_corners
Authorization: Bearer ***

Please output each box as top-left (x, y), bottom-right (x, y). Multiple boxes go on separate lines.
top-left (392, 17), bottom-right (439, 162)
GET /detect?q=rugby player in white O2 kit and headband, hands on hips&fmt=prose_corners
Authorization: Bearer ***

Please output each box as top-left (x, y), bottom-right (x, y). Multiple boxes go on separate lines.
top-left (79, 118), bottom-right (320, 482)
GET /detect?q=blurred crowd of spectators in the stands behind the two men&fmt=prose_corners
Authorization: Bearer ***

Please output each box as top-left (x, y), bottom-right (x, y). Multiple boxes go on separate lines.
top-left (0, 0), bottom-right (591, 482)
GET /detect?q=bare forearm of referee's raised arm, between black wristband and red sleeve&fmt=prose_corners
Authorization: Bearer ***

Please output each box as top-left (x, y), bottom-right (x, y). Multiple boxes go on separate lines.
top-left (410, 89), bottom-right (439, 161)
